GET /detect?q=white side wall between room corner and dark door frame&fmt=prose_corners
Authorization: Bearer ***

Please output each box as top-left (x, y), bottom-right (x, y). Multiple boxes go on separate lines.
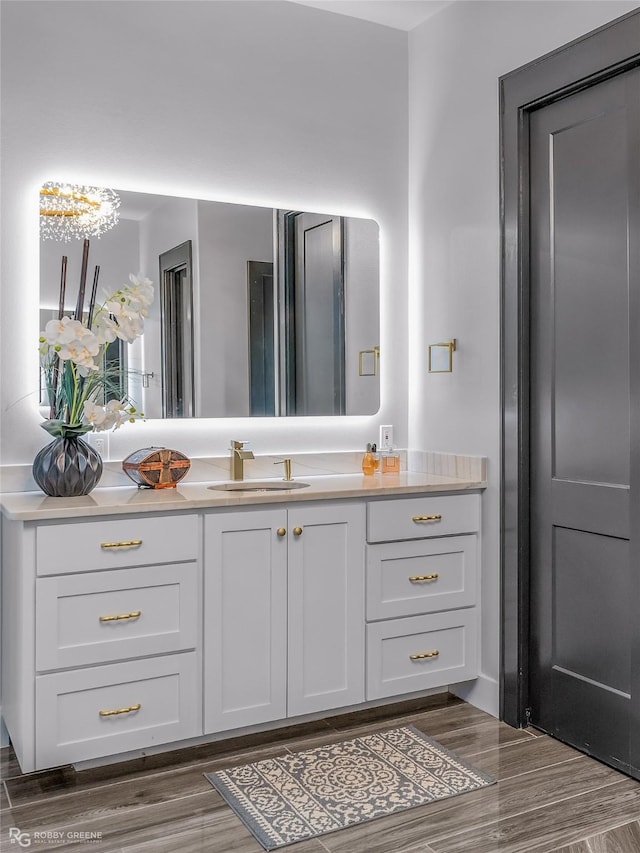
top-left (409, 0), bottom-right (640, 711)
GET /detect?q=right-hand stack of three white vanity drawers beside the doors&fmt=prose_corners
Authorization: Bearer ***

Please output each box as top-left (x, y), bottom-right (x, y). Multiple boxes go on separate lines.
top-left (366, 494), bottom-right (480, 700)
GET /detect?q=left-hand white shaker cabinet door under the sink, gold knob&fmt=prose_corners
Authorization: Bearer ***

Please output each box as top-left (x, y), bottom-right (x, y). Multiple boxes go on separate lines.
top-left (204, 509), bottom-right (288, 733)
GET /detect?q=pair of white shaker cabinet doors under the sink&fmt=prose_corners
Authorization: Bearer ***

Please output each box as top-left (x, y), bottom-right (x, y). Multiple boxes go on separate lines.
top-left (204, 501), bottom-right (365, 733)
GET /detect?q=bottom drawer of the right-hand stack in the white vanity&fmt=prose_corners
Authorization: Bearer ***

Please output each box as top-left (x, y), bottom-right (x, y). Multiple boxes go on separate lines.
top-left (367, 608), bottom-right (478, 700)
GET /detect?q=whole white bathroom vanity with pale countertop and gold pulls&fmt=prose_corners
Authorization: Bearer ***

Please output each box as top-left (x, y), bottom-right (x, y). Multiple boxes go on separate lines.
top-left (2, 473), bottom-right (485, 772)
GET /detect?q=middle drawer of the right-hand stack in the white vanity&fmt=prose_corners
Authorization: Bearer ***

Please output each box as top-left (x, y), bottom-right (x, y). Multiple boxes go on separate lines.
top-left (367, 535), bottom-right (478, 620)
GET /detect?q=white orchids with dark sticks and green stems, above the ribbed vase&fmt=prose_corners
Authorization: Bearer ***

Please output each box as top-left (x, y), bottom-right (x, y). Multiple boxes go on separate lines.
top-left (40, 260), bottom-right (154, 437)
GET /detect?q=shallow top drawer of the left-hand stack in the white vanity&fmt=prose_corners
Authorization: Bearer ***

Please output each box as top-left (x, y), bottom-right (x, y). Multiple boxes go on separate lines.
top-left (36, 515), bottom-right (198, 575)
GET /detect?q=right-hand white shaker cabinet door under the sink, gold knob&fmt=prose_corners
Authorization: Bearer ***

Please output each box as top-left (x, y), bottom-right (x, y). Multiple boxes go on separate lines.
top-left (287, 503), bottom-right (365, 717)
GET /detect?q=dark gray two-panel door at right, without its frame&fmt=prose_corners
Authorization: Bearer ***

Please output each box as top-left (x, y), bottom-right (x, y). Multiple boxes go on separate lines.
top-left (530, 70), bottom-right (640, 769)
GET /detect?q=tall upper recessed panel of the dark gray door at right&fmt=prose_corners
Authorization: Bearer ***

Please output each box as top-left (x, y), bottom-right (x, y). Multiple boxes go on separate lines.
top-left (552, 106), bottom-right (629, 484)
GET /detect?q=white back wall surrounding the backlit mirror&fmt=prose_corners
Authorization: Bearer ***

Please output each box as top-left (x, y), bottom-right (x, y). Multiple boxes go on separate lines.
top-left (0, 0), bottom-right (408, 464)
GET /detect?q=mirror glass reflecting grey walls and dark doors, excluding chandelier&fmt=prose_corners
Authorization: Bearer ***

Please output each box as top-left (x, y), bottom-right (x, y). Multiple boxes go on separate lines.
top-left (40, 190), bottom-right (380, 418)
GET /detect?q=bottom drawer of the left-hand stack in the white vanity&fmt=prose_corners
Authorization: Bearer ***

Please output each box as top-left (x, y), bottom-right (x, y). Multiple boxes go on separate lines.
top-left (36, 652), bottom-right (202, 768)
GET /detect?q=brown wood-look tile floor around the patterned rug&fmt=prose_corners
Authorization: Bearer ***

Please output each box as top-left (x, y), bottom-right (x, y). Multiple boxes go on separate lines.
top-left (0, 694), bottom-right (640, 853)
